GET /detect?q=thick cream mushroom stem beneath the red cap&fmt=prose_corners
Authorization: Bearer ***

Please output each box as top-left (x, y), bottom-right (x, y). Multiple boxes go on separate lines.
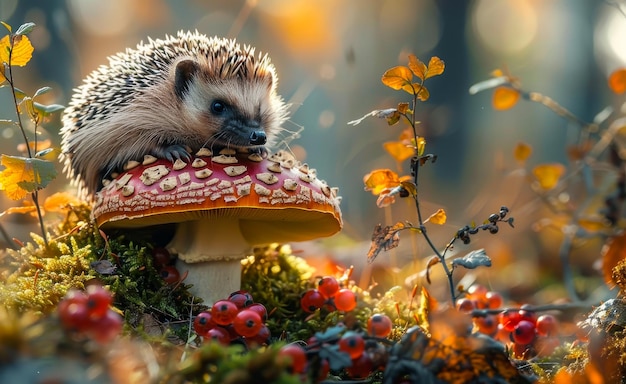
top-left (169, 217), bottom-right (251, 305)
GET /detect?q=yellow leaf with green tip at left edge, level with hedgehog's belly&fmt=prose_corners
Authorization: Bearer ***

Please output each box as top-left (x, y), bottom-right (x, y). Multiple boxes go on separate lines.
top-left (0, 155), bottom-right (56, 200)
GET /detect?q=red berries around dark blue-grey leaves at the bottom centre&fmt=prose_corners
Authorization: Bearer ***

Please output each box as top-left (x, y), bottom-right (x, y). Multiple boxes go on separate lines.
top-left (279, 314), bottom-right (392, 382)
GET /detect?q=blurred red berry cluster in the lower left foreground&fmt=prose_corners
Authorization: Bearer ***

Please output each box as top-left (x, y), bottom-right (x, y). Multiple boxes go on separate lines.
top-left (57, 285), bottom-right (123, 343)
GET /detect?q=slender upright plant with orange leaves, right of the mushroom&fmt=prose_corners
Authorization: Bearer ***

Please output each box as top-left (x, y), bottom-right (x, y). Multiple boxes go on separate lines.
top-left (348, 55), bottom-right (513, 303)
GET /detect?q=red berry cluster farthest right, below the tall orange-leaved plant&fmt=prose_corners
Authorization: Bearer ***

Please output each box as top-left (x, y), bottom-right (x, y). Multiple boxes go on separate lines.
top-left (456, 284), bottom-right (560, 358)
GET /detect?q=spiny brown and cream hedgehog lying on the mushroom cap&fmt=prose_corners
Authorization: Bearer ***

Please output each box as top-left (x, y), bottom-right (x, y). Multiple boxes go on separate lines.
top-left (60, 31), bottom-right (288, 199)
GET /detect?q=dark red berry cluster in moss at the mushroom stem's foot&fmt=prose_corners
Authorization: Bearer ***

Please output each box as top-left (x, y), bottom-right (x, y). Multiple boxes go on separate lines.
top-left (193, 291), bottom-right (270, 345)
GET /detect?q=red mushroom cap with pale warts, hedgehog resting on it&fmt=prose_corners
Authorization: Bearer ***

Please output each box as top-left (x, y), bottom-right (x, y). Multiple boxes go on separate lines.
top-left (92, 150), bottom-right (342, 245)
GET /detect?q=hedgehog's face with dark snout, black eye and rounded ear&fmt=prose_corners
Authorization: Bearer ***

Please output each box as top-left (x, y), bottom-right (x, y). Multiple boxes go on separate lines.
top-left (175, 60), bottom-right (284, 148)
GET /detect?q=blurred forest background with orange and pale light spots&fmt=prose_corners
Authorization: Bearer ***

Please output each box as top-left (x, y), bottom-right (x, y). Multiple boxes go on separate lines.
top-left (0, 0), bottom-right (626, 300)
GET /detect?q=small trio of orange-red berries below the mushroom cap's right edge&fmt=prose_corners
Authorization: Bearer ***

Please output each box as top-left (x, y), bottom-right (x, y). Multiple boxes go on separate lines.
top-left (300, 276), bottom-right (356, 313)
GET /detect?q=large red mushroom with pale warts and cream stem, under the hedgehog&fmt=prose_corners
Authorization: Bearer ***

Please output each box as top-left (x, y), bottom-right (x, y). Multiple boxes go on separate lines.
top-left (92, 150), bottom-right (342, 305)
